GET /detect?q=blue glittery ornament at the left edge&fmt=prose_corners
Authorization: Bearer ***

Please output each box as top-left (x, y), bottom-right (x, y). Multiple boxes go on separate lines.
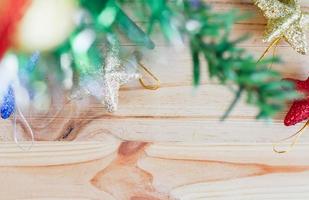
top-left (0, 86), bottom-right (15, 119)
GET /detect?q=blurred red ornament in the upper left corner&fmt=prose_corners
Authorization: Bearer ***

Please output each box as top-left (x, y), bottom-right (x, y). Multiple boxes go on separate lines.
top-left (0, 0), bottom-right (30, 59)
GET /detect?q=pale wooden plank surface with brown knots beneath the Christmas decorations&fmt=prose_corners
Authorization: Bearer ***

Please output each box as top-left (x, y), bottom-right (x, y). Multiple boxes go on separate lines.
top-left (0, 0), bottom-right (309, 200)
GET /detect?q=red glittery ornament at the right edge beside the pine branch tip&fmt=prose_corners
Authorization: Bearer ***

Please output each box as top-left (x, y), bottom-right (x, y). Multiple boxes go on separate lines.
top-left (284, 78), bottom-right (309, 126)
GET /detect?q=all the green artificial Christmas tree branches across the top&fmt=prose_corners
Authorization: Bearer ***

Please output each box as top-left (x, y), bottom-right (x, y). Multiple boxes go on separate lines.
top-left (0, 0), bottom-right (297, 119)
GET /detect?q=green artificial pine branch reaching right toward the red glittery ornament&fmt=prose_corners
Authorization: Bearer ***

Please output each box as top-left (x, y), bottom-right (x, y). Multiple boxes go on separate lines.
top-left (118, 0), bottom-right (298, 119)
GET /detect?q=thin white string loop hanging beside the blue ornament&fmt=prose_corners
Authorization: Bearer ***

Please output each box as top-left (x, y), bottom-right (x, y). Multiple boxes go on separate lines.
top-left (13, 106), bottom-right (34, 151)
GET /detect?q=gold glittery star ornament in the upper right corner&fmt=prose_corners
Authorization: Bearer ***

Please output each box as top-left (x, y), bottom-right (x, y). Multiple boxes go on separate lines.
top-left (254, 0), bottom-right (309, 54)
